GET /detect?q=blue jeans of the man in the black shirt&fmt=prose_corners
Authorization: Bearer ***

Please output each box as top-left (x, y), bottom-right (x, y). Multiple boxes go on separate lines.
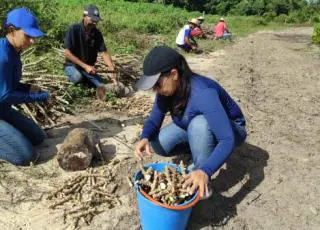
top-left (64, 65), bottom-right (102, 87)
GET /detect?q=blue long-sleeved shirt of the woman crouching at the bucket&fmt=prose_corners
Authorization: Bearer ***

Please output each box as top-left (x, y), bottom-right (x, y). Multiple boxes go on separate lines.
top-left (141, 74), bottom-right (246, 176)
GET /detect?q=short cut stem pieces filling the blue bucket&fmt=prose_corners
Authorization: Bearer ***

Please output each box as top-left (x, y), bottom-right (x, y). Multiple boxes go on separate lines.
top-left (136, 161), bottom-right (193, 205)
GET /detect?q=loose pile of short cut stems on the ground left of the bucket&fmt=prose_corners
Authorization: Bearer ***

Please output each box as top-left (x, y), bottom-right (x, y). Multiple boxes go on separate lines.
top-left (47, 168), bottom-right (121, 229)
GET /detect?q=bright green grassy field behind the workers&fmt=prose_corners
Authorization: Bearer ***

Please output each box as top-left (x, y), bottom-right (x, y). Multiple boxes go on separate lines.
top-left (53, 0), bottom-right (290, 54)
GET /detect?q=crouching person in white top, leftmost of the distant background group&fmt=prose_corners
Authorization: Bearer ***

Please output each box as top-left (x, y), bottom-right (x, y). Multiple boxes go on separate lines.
top-left (176, 18), bottom-right (199, 52)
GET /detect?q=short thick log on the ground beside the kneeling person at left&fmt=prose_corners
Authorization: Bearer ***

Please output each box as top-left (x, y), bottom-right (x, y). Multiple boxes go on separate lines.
top-left (57, 128), bottom-right (102, 171)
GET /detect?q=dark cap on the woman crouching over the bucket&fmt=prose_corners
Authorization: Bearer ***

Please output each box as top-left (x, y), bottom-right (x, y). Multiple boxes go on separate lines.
top-left (136, 46), bottom-right (181, 90)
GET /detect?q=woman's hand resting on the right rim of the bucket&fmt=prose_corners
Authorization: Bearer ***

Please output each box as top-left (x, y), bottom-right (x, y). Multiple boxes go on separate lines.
top-left (183, 169), bottom-right (209, 197)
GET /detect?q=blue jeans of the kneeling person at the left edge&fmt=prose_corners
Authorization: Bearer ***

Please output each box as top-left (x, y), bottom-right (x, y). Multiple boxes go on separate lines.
top-left (0, 108), bottom-right (46, 165)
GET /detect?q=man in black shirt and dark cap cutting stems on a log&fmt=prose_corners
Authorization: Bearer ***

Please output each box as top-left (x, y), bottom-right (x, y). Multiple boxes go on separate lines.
top-left (64, 5), bottom-right (117, 100)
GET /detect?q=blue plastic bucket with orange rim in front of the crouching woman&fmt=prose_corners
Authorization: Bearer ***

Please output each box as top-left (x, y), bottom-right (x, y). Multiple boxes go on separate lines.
top-left (134, 163), bottom-right (199, 230)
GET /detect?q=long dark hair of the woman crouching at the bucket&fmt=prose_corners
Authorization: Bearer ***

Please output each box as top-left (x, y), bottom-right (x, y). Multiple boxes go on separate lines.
top-left (169, 55), bottom-right (193, 117)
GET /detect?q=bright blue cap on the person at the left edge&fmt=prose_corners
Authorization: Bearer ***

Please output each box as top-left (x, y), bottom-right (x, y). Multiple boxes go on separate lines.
top-left (6, 8), bottom-right (44, 38)
